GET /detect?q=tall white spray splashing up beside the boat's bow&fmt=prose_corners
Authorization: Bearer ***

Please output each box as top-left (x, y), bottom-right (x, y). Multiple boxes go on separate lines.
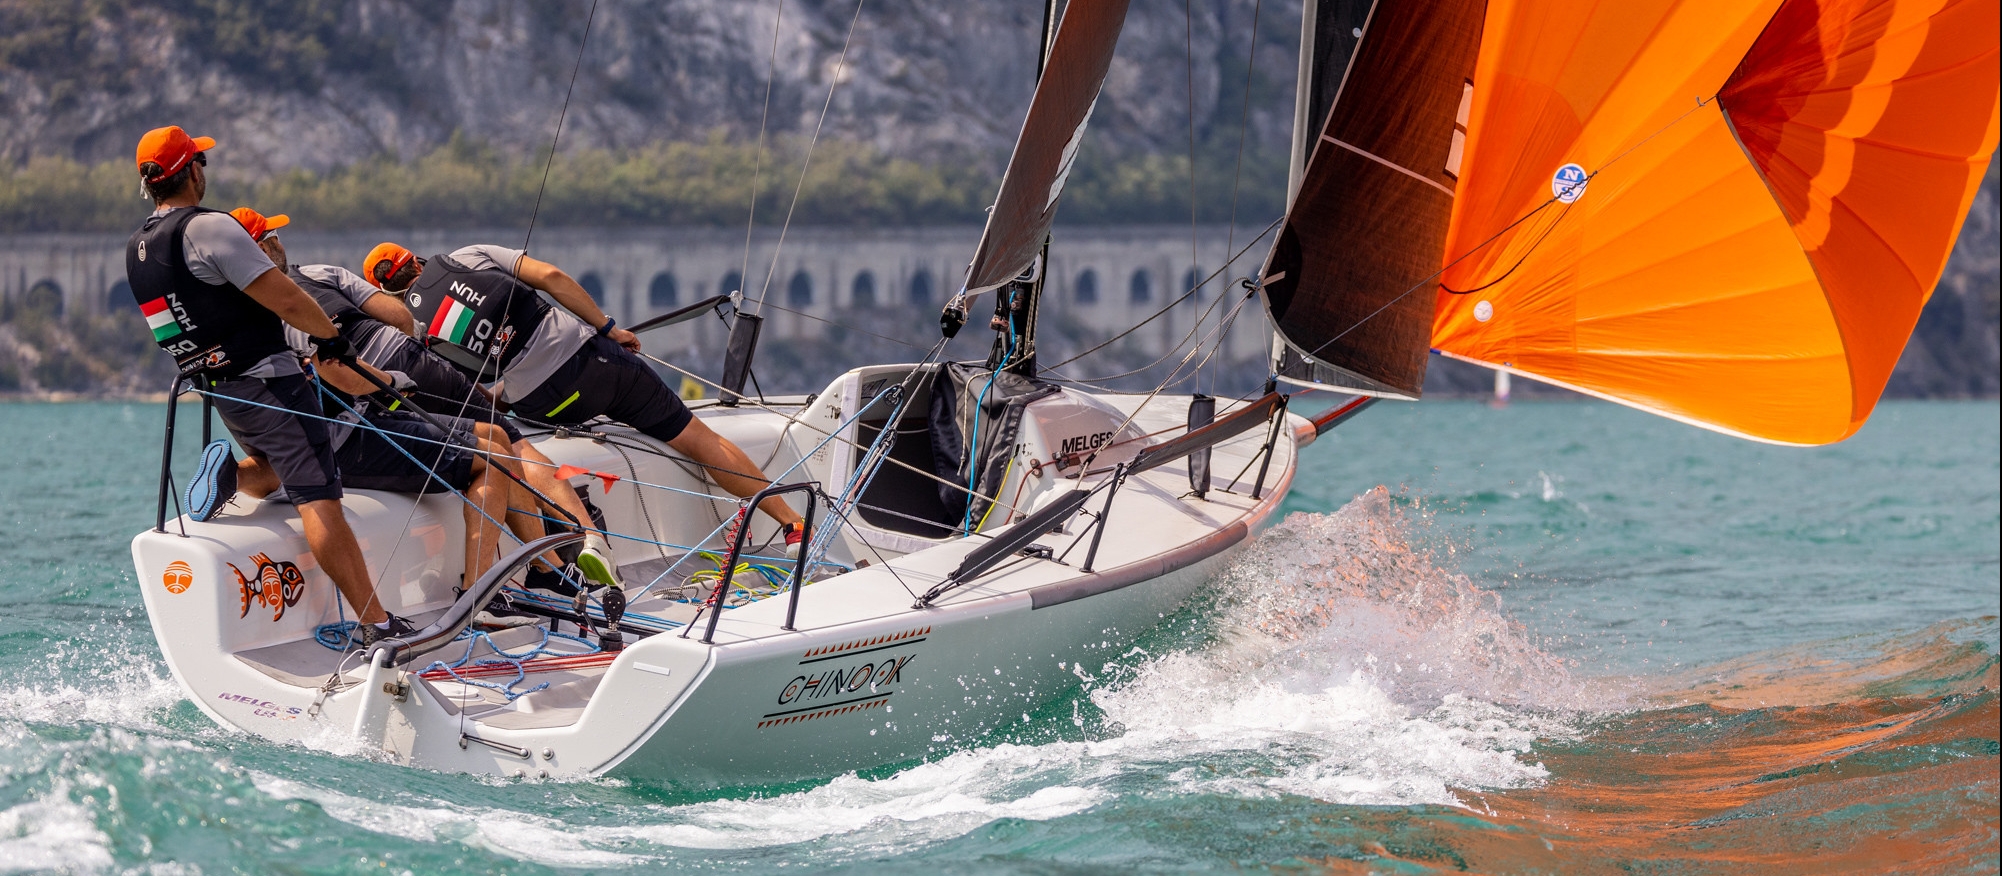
top-left (1091, 488), bottom-right (1580, 804)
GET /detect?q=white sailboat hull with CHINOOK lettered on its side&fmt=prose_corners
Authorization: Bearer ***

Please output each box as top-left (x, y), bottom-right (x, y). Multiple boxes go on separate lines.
top-left (132, 366), bottom-right (1313, 786)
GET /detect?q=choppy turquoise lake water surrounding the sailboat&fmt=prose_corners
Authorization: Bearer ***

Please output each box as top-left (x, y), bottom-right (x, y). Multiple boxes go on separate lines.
top-left (0, 402), bottom-right (2002, 874)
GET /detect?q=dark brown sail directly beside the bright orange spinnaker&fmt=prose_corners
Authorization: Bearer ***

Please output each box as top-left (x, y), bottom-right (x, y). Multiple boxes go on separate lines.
top-left (1263, 0), bottom-right (1487, 398)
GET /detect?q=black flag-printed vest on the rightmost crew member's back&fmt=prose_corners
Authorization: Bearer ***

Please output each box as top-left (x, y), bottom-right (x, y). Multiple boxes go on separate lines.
top-left (404, 256), bottom-right (549, 380)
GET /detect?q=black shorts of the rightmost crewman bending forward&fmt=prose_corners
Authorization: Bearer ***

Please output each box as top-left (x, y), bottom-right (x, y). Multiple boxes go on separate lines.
top-left (515, 338), bottom-right (695, 442)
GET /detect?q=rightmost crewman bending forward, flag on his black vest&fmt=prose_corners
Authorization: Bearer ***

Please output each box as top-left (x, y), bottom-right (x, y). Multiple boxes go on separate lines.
top-left (362, 242), bottom-right (803, 564)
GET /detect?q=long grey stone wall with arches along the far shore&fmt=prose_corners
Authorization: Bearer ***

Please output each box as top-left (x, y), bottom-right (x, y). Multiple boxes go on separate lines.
top-left (0, 226), bottom-right (1265, 380)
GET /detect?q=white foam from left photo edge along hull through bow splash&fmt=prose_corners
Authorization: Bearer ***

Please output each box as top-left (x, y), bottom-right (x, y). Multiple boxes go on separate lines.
top-left (0, 490), bottom-right (1578, 872)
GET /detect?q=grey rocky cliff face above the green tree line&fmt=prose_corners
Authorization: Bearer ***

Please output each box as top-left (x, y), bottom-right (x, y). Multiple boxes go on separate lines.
top-left (0, 0), bottom-right (1297, 174)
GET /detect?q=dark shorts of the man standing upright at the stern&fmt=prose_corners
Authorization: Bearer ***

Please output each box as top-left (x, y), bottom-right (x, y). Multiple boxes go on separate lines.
top-left (212, 374), bottom-right (340, 504)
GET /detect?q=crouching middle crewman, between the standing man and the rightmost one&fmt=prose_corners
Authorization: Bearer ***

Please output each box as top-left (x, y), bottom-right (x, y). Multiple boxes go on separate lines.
top-left (230, 206), bottom-right (615, 582)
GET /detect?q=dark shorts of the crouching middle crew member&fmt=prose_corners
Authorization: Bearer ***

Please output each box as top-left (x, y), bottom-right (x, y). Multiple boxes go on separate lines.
top-left (334, 412), bottom-right (474, 494)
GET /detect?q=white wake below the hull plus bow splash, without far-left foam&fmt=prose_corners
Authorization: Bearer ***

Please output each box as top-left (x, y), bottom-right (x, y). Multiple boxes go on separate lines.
top-left (242, 490), bottom-right (1580, 866)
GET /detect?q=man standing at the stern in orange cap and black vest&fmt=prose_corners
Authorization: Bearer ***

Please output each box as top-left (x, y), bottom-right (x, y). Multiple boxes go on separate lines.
top-left (126, 126), bottom-right (414, 644)
